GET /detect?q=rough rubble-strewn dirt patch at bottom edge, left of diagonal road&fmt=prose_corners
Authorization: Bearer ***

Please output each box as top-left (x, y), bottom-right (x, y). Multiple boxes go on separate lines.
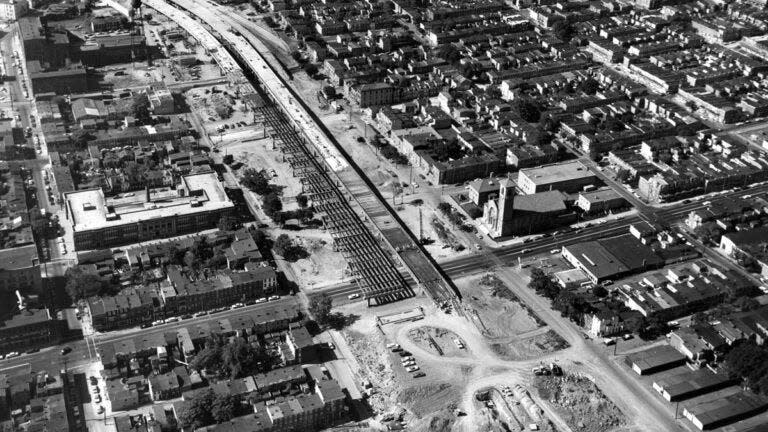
top-left (534, 375), bottom-right (624, 432)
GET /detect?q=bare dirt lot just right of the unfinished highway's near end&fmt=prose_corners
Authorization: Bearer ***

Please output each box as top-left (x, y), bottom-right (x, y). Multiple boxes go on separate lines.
top-left (456, 273), bottom-right (544, 340)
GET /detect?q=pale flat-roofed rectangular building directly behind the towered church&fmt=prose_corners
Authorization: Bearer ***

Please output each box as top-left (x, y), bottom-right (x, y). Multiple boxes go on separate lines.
top-left (517, 161), bottom-right (597, 195)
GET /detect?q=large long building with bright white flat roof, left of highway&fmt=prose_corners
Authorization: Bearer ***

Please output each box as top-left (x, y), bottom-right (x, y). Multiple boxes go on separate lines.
top-left (65, 172), bottom-right (234, 250)
